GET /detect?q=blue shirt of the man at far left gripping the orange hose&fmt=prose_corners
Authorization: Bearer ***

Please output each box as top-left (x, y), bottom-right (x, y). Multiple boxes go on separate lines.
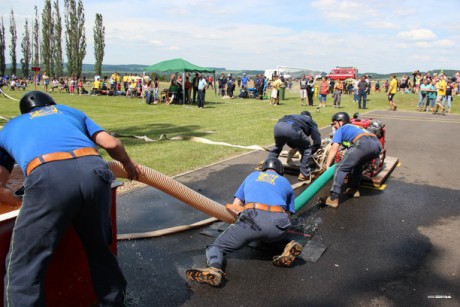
top-left (0, 105), bottom-right (104, 174)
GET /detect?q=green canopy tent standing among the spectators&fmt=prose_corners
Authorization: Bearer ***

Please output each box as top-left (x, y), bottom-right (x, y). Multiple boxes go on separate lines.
top-left (144, 58), bottom-right (216, 101)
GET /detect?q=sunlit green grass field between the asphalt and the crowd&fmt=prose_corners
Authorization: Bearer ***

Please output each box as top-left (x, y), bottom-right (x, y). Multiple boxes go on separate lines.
top-left (0, 84), bottom-right (456, 176)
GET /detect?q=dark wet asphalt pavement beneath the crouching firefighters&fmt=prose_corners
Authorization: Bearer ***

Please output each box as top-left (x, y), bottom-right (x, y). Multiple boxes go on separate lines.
top-left (117, 111), bottom-right (460, 306)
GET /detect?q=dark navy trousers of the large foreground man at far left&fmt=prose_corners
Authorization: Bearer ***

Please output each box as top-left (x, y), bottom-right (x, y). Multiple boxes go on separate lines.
top-left (4, 156), bottom-right (126, 306)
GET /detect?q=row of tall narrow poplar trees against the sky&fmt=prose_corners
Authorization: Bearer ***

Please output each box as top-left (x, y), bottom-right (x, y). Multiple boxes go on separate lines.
top-left (0, 0), bottom-right (105, 77)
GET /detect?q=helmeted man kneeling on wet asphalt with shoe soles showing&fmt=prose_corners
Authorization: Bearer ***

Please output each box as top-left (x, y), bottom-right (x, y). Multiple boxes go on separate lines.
top-left (186, 158), bottom-right (302, 287)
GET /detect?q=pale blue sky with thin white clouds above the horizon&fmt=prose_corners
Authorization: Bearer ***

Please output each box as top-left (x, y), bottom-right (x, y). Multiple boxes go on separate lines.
top-left (0, 0), bottom-right (460, 73)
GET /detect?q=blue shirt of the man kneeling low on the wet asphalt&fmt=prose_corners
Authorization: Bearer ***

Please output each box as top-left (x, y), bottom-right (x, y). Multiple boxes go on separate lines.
top-left (235, 170), bottom-right (295, 213)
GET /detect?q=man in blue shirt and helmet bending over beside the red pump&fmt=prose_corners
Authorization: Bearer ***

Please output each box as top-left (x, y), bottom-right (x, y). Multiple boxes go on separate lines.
top-left (325, 112), bottom-right (382, 208)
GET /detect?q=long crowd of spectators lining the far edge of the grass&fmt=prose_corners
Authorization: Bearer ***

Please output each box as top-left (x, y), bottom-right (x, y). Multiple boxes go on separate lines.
top-left (0, 70), bottom-right (460, 114)
